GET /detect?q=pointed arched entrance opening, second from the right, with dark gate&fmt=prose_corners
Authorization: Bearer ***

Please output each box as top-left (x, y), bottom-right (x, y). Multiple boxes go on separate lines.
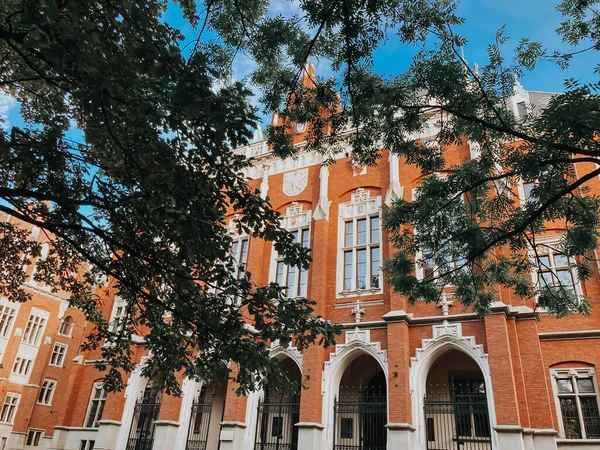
top-left (334, 354), bottom-right (387, 450)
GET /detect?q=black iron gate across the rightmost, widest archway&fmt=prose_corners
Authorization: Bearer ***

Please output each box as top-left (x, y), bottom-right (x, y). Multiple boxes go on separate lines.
top-left (424, 393), bottom-right (492, 450)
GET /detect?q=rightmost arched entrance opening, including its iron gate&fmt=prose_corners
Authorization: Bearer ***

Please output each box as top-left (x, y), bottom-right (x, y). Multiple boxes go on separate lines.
top-left (424, 350), bottom-right (492, 450)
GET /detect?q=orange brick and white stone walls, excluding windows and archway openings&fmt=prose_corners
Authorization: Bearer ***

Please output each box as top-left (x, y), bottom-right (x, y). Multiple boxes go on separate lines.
top-left (0, 72), bottom-right (600, 450)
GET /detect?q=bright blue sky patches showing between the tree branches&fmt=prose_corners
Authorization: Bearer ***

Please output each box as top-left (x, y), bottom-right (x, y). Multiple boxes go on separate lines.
top-left (0, 0), bottom-right (598, 129)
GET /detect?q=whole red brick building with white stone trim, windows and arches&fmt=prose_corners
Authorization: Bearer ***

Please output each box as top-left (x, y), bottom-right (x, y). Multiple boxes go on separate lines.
top-left (0, 64), bottom-right (600, 450)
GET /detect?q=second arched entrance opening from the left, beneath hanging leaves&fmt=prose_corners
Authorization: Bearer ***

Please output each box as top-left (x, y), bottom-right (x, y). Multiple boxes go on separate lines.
top-left (185, 381), bottom-right (227, 450)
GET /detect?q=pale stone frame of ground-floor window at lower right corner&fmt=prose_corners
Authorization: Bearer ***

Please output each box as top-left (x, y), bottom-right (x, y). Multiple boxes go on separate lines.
top-left (550, 367), bottom-right (600, 441)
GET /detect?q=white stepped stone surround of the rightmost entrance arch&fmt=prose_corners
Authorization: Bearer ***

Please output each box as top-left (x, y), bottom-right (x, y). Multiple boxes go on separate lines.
top-left (409, 320), bottom-right (498, 450)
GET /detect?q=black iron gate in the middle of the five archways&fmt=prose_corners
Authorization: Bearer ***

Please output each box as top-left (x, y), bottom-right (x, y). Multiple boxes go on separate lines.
top-left (254, 395), bottom-right (300, 450)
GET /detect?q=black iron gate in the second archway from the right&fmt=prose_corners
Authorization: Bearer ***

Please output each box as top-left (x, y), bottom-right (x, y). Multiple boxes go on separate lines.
top-left (333, 386), bottom-right (387, 450)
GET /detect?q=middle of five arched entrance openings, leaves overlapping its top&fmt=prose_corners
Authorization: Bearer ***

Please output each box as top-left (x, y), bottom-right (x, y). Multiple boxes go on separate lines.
top-left (254, 357), bottom-right (302, 450)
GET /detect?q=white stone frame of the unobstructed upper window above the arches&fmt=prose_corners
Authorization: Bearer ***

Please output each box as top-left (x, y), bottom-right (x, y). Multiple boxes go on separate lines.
top-left (336, 188), bottom-right (383, 298)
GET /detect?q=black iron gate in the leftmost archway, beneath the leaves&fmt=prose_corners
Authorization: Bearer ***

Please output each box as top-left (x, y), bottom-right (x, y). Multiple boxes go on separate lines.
top-left (127, 388), bottom-right (162, 450)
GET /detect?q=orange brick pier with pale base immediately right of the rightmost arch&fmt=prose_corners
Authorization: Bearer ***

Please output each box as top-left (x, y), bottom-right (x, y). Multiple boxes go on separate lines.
top-left (484, 314), bottom-right (524, 450)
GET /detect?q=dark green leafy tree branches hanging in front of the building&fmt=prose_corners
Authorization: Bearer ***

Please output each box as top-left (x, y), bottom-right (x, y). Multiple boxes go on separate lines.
top-left (0, 0), bottom-right (600, 391)
